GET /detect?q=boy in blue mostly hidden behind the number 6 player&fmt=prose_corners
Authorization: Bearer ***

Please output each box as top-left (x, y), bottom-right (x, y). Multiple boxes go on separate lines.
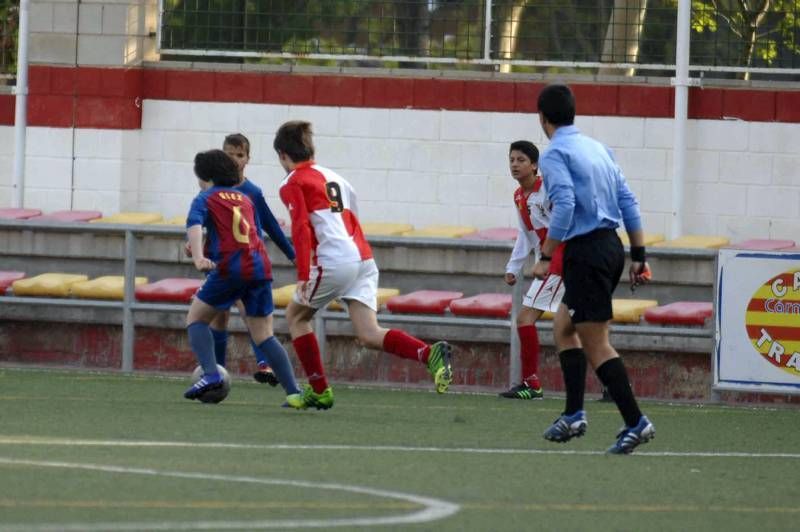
top-left (202, 133), bottom-right (295, 386)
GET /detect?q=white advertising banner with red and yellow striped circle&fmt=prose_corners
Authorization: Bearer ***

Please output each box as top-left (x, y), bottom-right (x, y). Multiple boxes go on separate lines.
top-left (713, 249), bottom-right (800, 394)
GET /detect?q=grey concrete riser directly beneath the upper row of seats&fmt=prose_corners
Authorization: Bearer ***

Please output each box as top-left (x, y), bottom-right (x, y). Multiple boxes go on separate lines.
top-left (0, 220), bottom-right (717, 303)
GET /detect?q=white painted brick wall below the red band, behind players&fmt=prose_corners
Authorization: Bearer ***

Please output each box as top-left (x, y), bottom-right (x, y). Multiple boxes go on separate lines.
top-left (0, 100), bottom-right (800, 242)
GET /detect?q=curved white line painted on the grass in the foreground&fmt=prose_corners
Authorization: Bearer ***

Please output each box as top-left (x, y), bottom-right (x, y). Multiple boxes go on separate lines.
top-left (0, 457), bottom-right (461, 532)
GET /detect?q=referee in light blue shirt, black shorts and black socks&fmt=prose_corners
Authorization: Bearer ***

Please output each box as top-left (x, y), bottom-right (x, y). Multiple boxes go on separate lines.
top-left (533, 85), bottom-right (655, 454)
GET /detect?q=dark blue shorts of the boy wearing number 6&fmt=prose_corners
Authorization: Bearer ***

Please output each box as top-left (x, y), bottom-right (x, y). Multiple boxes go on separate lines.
top-left (195, 271), bottom-right (275, 317)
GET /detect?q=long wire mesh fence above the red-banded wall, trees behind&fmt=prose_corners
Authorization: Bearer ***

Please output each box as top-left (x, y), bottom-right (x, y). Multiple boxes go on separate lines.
top-left (159, 0), bottom-right (800, 79)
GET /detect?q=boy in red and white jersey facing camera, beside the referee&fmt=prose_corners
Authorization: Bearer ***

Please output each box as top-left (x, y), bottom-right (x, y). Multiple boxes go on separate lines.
top-left (500, 140), bottom-right (564, 399)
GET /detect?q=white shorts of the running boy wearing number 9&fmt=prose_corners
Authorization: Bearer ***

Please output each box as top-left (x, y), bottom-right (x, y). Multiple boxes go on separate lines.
top-left (292, 259), bottom-right (378, 312)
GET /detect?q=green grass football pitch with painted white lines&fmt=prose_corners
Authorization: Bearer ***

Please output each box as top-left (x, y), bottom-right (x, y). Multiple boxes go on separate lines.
top-left (0, 368), bottom-right (800, 531)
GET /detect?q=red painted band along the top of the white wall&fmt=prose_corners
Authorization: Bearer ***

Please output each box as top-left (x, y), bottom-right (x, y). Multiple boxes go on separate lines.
top-left (0, 65), bottom-right (800, 129)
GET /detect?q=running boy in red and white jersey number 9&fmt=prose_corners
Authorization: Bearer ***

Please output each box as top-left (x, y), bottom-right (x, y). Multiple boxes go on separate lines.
top-left (273, 121), bottom-right (453, 409)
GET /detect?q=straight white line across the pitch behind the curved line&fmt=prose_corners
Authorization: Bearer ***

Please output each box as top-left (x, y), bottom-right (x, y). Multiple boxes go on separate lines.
top-left (0, 436), bottom-right (800, 459)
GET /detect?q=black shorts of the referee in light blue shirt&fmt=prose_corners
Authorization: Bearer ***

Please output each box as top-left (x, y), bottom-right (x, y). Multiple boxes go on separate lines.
top-left (562, 229), bottom-right (625, 323)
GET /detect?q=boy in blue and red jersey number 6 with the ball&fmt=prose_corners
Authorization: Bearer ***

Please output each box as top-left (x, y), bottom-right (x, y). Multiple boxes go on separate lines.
top-left (184, 150), bottom-right (299, 399)
